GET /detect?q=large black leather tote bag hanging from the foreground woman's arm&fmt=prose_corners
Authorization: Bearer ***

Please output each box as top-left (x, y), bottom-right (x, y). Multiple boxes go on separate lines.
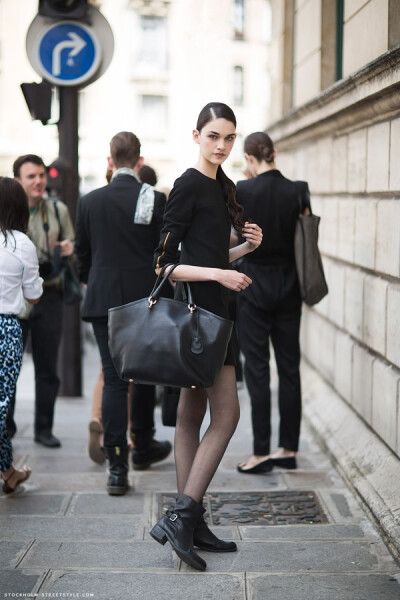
top-left (108, 265), bottom-right (233, 388)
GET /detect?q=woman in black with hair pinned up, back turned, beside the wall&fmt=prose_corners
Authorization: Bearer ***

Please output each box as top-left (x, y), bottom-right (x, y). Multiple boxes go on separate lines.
top-left (237, 132), bottom-right (310, 473)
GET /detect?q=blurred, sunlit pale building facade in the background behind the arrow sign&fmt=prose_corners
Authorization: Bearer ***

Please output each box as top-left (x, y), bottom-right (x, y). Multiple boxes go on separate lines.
top-left (0, 0), bottom-right (271, 192)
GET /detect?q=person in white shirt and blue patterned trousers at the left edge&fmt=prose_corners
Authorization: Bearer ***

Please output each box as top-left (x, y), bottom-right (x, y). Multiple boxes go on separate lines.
top-left (0, 177), bottom-right (43, 494)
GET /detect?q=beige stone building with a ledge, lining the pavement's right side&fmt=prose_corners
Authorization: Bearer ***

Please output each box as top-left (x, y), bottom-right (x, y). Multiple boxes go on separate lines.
top-left (268, 0), bottom-right (400, 553)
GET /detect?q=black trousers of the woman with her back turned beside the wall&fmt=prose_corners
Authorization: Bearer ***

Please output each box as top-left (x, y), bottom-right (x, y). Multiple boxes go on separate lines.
top-left (237, 264), bottom-right (301, 455)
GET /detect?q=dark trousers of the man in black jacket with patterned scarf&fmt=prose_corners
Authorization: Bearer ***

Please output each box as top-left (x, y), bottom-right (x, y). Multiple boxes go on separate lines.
top-left (92, 317), bottom-right (156, 446)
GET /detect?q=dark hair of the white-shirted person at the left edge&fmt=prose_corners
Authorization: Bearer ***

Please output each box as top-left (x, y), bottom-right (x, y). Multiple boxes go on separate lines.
top-left (0, 177), bottom-right (29, 245)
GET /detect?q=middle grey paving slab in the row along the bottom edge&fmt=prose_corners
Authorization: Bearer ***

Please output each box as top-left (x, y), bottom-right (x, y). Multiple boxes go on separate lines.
top-left (41, 572), bottom-right (245, 600)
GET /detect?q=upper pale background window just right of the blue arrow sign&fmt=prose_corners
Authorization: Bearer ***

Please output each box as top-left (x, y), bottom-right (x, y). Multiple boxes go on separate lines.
top-left (138, 15), bottom-right (167, 71)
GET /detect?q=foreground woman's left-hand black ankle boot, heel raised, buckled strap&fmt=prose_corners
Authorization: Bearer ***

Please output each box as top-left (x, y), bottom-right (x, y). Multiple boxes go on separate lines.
top-left (150, 494), bottom-right (207, 571)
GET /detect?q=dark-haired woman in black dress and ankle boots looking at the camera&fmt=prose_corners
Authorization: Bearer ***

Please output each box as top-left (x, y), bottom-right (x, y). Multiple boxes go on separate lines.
top-left (150, 102), bottom-right (262, 570)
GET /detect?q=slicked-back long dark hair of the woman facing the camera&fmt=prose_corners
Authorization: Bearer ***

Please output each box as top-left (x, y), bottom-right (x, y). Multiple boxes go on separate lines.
top-left (196, 102), bottom-right (243, 232)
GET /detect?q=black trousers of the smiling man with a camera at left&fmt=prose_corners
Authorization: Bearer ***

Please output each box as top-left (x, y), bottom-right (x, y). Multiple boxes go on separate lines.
top-left (7, 287), bottom-right (63, 435)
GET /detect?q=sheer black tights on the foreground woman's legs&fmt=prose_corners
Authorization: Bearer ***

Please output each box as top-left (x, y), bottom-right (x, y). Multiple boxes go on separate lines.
top-left (175, 365), bottom-right (240, 502)
